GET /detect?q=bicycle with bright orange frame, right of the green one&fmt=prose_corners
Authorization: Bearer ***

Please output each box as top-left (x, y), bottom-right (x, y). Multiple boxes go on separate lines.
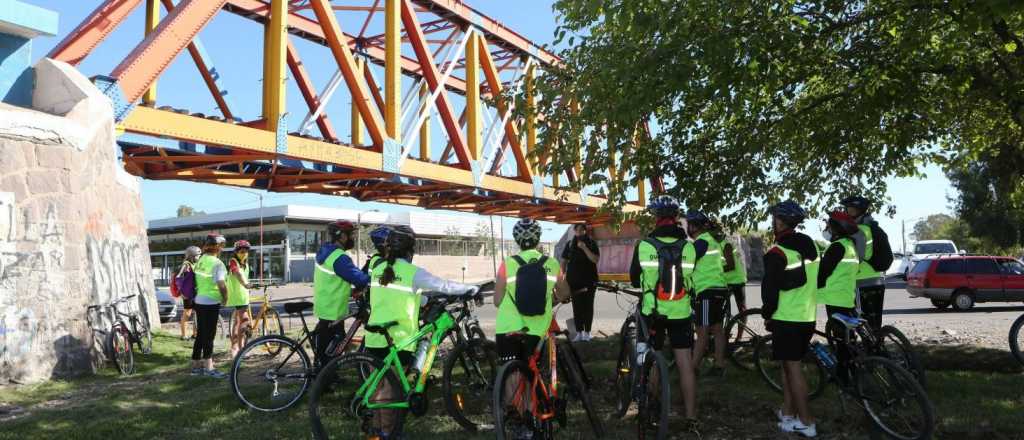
top-left (492, 304), bottom-right (604, 440)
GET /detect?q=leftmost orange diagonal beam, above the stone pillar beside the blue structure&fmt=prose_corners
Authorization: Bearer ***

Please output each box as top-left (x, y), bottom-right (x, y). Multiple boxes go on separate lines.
top-left (46, 0), bottom-right (142, 65)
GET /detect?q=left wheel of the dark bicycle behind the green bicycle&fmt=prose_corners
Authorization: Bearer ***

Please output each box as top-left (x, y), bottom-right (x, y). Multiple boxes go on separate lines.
top-left (231, 336), bottom-right (312, 412)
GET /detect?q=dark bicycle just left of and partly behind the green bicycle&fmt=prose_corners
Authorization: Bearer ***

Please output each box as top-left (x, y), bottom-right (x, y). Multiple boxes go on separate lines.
top-left (230, 296), bottom-right (370, 412)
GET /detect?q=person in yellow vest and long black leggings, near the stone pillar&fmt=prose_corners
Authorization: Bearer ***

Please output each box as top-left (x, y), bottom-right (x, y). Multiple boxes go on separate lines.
top-left (191, 233), bottom-right (227, 379)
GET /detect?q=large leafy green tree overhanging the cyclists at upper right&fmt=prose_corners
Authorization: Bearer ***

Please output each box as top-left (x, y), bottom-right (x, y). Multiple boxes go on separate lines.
top-left (517, 0), bottom-right (1024, 225)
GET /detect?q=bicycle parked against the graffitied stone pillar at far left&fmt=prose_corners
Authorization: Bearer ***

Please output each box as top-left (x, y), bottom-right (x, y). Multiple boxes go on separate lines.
top-left (86, 295), bottom-right (153, 376)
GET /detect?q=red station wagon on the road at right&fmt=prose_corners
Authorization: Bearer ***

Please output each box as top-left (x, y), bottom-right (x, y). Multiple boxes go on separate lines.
top-left (906, 255), bottom-right (1024, 310)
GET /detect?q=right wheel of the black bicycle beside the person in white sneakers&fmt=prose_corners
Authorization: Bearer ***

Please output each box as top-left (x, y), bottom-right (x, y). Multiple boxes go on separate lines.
top-left (854, 356), bottom-right (935, 440)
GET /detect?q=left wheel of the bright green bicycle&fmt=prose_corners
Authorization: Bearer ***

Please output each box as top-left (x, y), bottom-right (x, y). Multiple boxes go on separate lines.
top-left (309, 353), bottom-right (406, 439)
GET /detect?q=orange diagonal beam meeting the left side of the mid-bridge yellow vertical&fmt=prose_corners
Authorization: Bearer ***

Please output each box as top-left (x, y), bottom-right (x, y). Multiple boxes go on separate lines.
top-left (311, 0), bottom-right (384, 148)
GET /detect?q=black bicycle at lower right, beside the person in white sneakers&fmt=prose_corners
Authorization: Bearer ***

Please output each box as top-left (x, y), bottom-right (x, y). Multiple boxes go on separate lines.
top-left (811, 313), bottom-right (935, 440)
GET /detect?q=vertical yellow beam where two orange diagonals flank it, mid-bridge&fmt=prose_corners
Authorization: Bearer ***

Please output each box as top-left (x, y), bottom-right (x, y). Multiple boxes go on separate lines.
top-left (384, 0), bottom-right (401, 142)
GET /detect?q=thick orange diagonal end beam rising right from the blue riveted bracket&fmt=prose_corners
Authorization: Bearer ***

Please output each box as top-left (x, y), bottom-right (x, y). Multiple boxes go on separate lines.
top-left (111, 0), bottom-right (226, 102)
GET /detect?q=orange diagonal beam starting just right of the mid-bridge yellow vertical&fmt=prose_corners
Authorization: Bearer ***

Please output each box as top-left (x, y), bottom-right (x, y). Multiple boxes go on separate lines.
top-left (401, 0), bottom-right (474, 169)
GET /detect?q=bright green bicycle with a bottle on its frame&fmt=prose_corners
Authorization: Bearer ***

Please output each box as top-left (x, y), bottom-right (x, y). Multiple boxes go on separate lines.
top-left (309, 290), bottom-right (493, 439)
